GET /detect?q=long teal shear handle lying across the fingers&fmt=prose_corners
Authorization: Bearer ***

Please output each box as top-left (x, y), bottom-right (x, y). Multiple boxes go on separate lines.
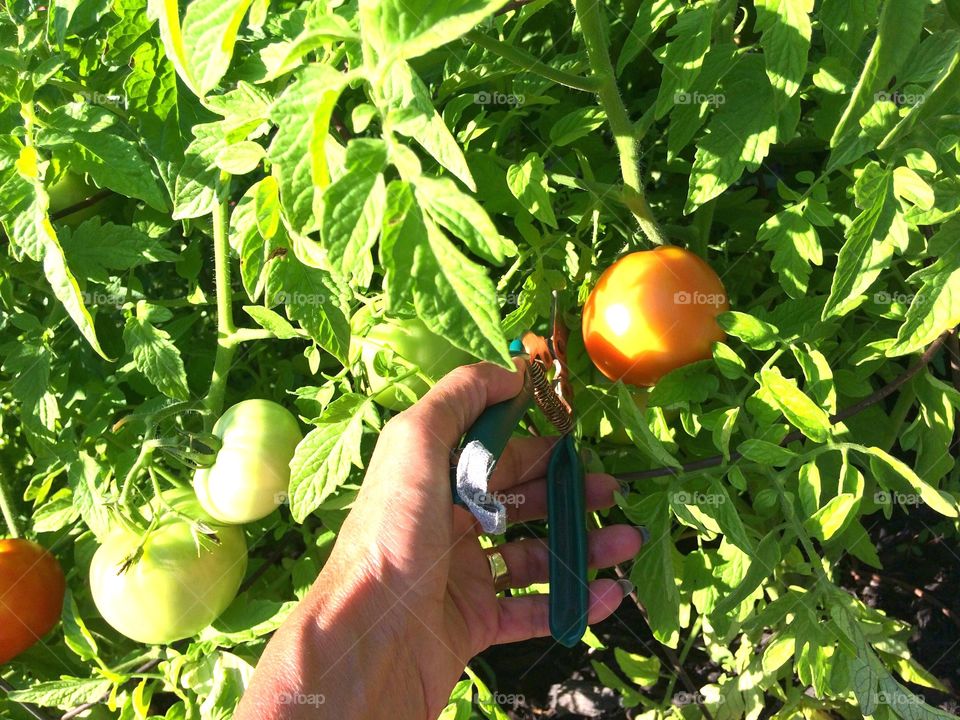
top-left (547, 433), bottom-right (590, 647)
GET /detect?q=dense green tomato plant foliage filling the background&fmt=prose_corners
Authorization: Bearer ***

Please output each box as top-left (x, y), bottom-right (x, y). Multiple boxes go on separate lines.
top-left (0, 0), bottom-right (960, 720)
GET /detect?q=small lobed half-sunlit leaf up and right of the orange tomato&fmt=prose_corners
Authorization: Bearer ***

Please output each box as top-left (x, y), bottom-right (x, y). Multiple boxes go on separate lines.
top-left (757, 205), bottom-right (823, 298)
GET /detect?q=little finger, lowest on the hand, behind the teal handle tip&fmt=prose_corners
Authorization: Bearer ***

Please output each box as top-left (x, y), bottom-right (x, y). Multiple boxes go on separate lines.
top-left (493, 579), bottom-right (626, 645)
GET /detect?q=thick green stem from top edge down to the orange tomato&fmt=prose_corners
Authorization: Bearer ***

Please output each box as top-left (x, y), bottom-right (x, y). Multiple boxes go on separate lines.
top-left (574, 0), bottom-right (667, 245)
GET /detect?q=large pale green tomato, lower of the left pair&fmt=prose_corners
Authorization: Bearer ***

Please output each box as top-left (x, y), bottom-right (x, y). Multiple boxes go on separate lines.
top-left (90, 489), bottom-right (247, 644)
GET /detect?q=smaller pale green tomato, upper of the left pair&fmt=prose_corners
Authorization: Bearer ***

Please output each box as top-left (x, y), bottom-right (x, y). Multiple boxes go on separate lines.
top-left (193, 400), bottom-right (303, 524)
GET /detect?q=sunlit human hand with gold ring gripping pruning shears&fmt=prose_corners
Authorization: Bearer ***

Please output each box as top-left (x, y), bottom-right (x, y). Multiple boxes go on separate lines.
top-left (237, 363), bottom-right (642, 719)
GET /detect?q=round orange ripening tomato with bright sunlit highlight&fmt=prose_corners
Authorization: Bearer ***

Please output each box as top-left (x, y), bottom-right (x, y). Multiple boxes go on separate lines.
top-left (583, 246), bottom-right (729, 386)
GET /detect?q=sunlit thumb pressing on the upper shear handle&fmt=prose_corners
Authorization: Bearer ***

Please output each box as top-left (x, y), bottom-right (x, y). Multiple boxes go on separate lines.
top-left (391, 360), bottom-right (523, 463)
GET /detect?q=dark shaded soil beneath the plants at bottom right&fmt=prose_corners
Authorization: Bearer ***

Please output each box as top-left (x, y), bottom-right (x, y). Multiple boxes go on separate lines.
top-left (476, 507), bottom-right (960, 720)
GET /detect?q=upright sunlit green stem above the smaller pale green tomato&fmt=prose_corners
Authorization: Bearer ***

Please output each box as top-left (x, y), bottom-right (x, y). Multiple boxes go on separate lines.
top-left (203, 173), bottom-right (237, 430)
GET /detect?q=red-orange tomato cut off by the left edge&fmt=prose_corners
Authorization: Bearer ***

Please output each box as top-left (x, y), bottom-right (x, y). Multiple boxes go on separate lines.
top-left (0, 539), bottom-right (67, 664)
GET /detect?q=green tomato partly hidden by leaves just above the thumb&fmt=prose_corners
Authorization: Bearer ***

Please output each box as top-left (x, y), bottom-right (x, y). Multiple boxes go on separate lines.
top-left (351, 305), bottom-right (477, 411)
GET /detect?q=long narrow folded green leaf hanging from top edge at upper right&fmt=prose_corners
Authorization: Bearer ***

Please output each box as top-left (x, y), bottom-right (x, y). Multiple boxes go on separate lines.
top-left (830, 0), bottom-right (927, 148)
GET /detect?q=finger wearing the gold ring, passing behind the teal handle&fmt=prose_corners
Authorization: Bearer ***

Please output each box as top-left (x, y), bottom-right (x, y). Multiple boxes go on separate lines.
top-left (496, 525), bottom-right (643, 588)
